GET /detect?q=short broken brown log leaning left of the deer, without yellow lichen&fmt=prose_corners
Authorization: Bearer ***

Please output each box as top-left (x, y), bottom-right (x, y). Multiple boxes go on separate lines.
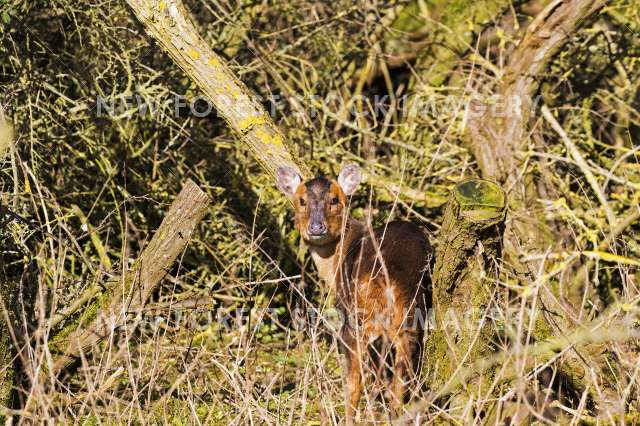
top-left (49, 180), bottom-right (209, 373)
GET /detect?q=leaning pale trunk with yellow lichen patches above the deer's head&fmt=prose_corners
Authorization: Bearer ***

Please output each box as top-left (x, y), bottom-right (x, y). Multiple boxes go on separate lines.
top-left (127, 0), bottom-right (309, 182)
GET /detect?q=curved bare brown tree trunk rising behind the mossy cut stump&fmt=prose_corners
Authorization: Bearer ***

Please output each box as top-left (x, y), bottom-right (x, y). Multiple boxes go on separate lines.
top-left (467, 0), bottom-right (605, 318)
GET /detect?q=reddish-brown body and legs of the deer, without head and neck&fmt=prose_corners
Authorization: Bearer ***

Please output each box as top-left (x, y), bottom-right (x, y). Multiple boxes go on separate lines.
top-left (336, 221), bottom-right (431, 419)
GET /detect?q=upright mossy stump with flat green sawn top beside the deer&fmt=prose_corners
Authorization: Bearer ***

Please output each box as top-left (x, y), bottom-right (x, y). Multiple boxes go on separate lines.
top-left (425, 179), bottom-right (507, 406)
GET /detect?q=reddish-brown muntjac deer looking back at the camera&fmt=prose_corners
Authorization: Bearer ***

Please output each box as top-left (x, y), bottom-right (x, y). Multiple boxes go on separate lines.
top-left (277, 165), bottom-right (431, 424)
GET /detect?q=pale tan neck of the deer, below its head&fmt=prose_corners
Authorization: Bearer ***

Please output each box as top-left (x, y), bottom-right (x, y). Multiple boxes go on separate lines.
top-left (309, 216), bottom-right (364, 288)
